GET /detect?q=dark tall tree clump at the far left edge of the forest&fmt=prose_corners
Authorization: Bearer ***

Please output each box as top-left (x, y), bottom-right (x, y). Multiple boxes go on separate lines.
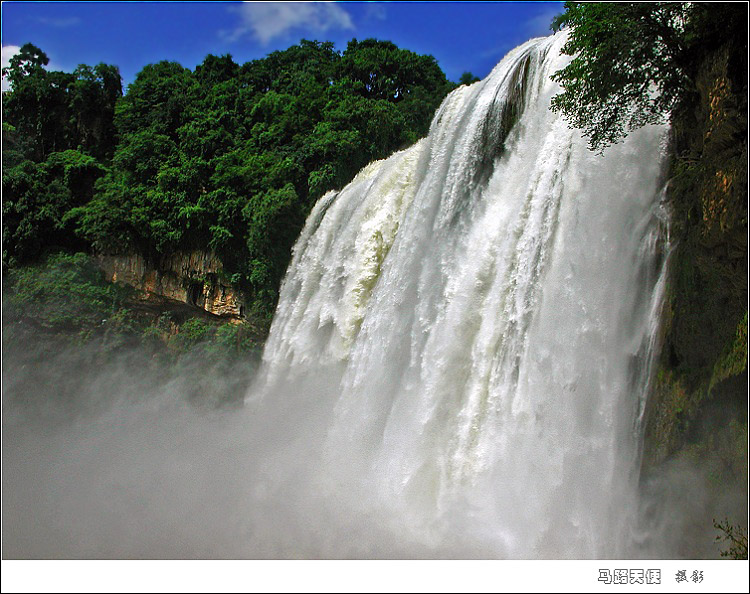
top-left (3, 44), bottom-right (122, 265)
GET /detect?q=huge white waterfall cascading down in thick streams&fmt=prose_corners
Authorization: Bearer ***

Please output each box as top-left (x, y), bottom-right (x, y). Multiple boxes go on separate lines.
top-left (247, 34), bottom-right (665, 558)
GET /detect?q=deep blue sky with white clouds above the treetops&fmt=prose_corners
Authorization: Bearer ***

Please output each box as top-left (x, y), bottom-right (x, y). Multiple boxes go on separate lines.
top-left (2, 1), bottom-right (562, 88)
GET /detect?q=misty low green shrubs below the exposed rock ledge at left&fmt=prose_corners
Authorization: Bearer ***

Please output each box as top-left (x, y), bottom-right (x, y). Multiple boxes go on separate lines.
top-left (3, 252), bottom-right (264, 359)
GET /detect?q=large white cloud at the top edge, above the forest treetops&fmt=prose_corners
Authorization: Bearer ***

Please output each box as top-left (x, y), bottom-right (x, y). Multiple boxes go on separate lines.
top-left (224, 2), bottom-right (354, 45)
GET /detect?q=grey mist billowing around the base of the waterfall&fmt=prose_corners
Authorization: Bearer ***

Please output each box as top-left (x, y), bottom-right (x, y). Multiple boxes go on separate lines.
top-left (2, 326), bottom-right (746, 559)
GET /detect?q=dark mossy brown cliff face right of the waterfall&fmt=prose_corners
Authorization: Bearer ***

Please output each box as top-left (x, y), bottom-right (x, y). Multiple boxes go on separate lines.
top-left (644, 31), bottom-right (748, 552)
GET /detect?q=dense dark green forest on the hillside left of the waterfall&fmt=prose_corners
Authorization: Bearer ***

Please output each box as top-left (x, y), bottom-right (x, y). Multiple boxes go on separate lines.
top-left (3, 39), bottom-right (454, 310)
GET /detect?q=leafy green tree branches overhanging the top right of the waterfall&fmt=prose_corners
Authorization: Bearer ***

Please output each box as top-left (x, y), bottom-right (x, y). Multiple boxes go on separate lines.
top-left (552, 2), bottom-right (746, 151)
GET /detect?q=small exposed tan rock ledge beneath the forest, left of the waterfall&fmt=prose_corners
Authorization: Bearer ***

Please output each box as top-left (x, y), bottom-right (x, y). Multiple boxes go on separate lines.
top-left (97, 251), bottom-right (245, 321)
